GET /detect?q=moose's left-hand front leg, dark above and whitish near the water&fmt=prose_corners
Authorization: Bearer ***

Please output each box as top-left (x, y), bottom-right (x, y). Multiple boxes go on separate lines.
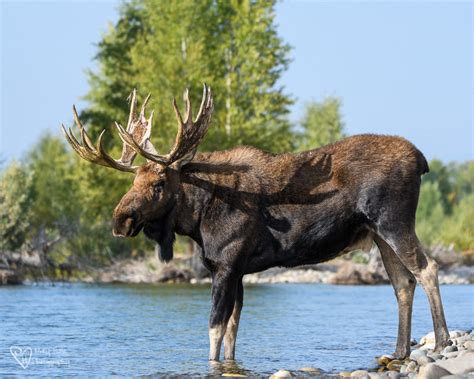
top-left (209, 272), bottom-right (239, 361)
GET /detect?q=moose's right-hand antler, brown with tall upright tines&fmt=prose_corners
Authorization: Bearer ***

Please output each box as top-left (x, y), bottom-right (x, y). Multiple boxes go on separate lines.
top-left (115, 84), bottom-right (214, 166)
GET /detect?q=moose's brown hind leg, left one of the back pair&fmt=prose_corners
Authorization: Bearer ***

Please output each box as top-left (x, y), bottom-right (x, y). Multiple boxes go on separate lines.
top-left (374, 236), bottom-right (416, 359)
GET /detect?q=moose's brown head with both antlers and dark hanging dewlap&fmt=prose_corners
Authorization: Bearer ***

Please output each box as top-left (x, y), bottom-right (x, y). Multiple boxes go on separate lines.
top-left (62, 84), bottom-right (213, 261)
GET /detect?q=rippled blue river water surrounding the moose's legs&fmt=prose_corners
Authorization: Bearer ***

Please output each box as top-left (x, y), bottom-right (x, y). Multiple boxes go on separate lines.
top-left (0, 284), bottom-right (474, 377)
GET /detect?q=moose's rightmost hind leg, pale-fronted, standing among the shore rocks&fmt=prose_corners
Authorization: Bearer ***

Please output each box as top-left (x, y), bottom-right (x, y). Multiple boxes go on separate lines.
top-left (384, 228), bottom-right (450, 351)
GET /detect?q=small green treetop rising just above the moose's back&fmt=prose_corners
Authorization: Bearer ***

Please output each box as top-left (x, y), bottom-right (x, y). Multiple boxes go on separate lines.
top-left (298, 97), bottom-right (345, 150)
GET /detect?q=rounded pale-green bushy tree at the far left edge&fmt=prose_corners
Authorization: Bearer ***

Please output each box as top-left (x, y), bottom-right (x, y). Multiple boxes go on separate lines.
top-left (0, 162), bottom-right (33, 251)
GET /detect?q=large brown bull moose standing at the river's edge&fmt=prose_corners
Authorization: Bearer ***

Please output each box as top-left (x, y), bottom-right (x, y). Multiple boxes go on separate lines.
top-left (62, 84), bottom-right (451, 361)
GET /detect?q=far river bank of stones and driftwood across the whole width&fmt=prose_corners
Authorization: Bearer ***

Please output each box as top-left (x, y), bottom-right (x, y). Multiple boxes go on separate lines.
top-left (0, 247), bottom-right (474, 285)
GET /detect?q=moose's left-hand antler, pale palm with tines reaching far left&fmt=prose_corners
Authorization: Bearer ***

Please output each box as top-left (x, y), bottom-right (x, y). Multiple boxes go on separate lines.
top-left (61, 90), bottom-right (155, 172)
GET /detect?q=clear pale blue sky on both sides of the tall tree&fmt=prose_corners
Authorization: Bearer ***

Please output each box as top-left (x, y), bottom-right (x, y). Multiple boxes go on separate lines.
top-left (0, 0), bottom-right (474, 162)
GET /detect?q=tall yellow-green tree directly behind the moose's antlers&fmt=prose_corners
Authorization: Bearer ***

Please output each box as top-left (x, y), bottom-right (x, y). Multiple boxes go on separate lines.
top-left (75, 0), bottom-right (293, 255)
